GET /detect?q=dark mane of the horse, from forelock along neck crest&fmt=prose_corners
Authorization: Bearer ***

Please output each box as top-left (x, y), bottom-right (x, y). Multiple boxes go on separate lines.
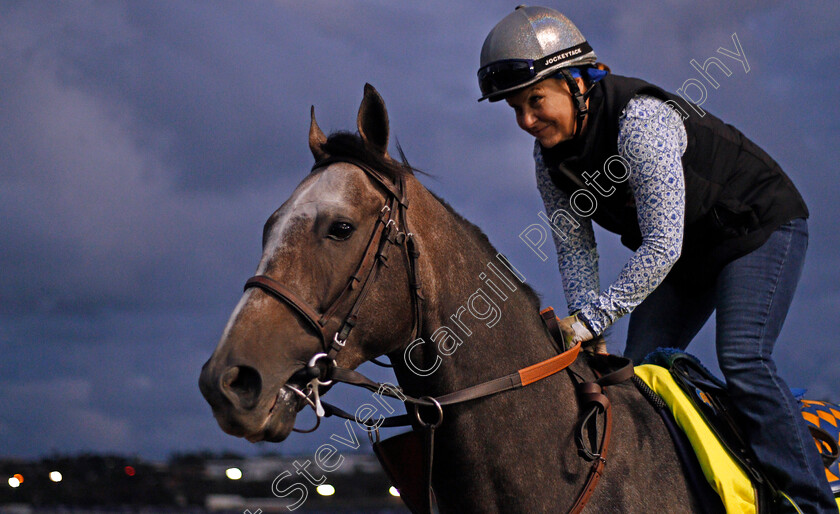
top-left (321, 131), bottom-right (541, 310)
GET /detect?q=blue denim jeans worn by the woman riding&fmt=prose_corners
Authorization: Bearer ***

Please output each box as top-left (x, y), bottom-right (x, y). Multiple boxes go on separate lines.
top-left (624, 218), bottom-right (837, 513)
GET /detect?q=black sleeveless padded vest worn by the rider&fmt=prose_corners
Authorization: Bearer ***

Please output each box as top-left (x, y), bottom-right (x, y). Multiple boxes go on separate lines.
top-left (542, 74), bottom-right (808, 283)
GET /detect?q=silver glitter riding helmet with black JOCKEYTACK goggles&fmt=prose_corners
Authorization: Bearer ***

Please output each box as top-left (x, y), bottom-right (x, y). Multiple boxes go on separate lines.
top-left (478, 5), bottom-right (597, 102)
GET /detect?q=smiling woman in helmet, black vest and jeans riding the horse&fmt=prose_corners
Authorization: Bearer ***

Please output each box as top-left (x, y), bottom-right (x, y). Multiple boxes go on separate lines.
top-left (478, 6), bottom-right (837, 513)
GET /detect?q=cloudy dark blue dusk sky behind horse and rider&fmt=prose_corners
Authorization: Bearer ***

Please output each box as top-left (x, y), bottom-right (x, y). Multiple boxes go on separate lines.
top-left (0, 0), bottom-right (840, 458)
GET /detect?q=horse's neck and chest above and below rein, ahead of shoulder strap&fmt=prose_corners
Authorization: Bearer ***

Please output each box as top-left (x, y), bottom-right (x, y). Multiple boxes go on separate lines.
top-left (384, 176), bottom-right (608, 512)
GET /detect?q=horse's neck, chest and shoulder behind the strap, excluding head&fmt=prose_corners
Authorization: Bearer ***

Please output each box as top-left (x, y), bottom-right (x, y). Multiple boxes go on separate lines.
top-left (376, 181), bottom-right (699, 512)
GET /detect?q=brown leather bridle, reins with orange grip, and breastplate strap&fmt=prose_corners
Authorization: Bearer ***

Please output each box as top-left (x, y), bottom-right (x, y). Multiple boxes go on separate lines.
top-left (244, 157), bottom-right (633, 513)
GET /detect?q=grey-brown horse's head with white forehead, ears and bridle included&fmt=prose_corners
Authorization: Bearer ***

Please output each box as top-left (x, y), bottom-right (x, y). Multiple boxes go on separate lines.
top-left (199, 85), bottom-right (420, 442)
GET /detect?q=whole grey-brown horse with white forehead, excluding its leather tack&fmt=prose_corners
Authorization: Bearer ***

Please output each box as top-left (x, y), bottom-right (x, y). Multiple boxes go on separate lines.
top-left (199, 86), bottom-right (701, 513)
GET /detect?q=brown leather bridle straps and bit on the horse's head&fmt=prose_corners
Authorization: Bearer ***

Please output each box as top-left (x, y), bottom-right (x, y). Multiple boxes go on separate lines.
top-left (245, 157), bottom-right (423, 424)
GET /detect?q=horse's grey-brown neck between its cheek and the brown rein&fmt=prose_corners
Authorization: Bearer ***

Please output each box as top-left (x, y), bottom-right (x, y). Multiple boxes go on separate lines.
top-left (394, 179), bottom-right (556, 395)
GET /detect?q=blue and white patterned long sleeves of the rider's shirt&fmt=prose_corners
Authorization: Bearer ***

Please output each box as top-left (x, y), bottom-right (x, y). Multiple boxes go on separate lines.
top-left (534, 95), bottom-right (687, 334)
